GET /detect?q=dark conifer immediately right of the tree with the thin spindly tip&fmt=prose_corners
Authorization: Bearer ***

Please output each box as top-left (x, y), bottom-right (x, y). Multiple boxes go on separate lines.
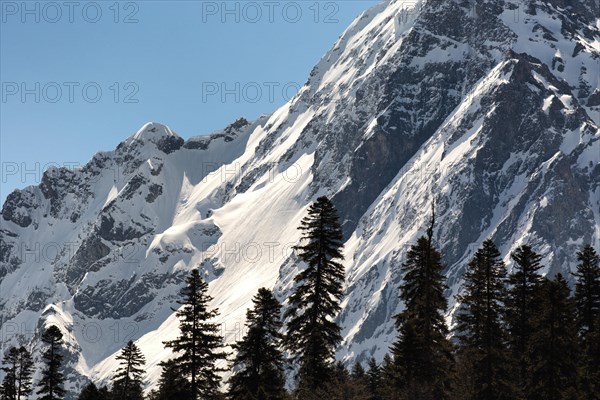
top-left (456, 240), bottom-right (515, 400)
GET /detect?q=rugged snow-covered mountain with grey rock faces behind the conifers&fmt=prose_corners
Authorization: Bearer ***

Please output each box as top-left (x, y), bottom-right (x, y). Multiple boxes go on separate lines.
top-left (0, 0), bottom-right (600, 394)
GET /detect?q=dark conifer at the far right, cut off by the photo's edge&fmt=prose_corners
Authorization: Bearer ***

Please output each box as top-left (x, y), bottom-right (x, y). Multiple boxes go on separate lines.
top-left (574, 245), bottom-right (600, 399)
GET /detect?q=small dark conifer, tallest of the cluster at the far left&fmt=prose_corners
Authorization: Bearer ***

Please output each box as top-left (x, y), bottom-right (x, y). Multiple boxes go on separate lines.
top-left (36, 325), bottom-right (65, 400)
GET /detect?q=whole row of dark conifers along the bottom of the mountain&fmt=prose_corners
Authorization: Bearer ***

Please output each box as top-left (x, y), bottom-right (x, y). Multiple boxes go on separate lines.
top-left (0, 197), bottom-right (600, 400)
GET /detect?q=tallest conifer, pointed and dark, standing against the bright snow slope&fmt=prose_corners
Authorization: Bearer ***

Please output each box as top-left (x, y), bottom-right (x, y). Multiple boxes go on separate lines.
top-left (284, 197), bottom-right (344, 392)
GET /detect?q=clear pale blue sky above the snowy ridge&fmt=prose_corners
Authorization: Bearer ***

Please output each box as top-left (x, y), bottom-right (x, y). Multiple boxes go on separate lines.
top-left (0, 0), bottom-right (377, 202)
